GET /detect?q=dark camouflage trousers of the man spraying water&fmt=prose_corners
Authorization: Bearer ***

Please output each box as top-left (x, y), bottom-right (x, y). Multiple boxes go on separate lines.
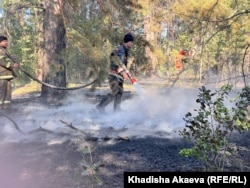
top-left (97, 75), bottom-right (123, 112)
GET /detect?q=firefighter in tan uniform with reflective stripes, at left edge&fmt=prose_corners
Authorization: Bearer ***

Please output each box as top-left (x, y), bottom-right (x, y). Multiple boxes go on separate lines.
top-left (0, 36), bottom-right (20, 109)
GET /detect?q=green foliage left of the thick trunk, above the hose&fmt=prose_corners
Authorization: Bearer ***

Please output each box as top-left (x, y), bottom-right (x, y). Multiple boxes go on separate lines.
top-left (0, 0), bottom-right (41, 83)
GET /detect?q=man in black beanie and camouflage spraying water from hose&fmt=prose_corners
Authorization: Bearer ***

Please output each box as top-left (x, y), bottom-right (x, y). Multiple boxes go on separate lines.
top-left (96, 33), bottom-right (134, 113)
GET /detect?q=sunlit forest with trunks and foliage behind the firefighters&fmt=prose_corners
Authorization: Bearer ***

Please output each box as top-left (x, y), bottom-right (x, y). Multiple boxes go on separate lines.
top-left (0, 0), bottom-right (250, 98)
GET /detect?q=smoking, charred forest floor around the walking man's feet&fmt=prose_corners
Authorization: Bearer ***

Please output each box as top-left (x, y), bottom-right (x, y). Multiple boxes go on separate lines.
top-left (0, 87), bottom-right (250, 188)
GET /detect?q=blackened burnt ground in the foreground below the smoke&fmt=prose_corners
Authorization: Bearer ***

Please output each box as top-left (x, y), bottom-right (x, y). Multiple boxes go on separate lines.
top-left (0, 88), bottom-right (250, 188)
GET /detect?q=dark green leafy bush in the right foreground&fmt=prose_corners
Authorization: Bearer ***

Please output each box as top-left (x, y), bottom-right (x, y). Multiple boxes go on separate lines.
top-left (179, 85), bottom-right (250, 171)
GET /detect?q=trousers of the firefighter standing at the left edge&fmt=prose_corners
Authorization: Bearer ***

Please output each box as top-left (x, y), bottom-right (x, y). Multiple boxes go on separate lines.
top-left (0, 79), bottom-right (12, 109)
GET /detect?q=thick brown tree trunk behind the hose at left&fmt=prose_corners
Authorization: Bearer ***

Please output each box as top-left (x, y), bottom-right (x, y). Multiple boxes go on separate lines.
top-left (41, 0), bottom-right (66, 99)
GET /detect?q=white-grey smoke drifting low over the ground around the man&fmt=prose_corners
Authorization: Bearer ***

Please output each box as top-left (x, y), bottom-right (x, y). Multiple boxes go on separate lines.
top-left (0, 84), bottom-right (198, 141)
